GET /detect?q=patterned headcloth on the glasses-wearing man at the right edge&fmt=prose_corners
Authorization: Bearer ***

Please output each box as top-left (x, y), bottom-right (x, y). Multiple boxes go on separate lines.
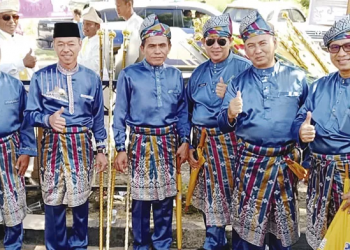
top-left (323, 15), bottom-right (350, 47)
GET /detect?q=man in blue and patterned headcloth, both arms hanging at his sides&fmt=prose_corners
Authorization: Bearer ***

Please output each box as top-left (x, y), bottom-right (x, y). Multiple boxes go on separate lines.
top-left (113, 14), bottom-right (190, 250)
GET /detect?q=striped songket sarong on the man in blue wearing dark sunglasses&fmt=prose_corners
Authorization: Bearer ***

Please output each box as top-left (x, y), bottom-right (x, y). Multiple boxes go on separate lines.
top-left (193, 127), bottom-right (237, 227)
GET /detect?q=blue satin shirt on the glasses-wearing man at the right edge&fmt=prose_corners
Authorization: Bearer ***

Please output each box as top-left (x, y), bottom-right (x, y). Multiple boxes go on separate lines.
top-left (293, 72), bottom-right (350, 155)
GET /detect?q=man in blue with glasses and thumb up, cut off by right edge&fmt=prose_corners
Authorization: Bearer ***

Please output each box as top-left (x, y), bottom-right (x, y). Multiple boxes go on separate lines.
top-left (293, 15), bottom-right (350, 249)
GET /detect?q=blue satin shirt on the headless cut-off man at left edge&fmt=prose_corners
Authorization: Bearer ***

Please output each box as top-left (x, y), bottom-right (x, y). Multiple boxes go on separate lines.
top-left (0, 72), bottom-right (37, 156)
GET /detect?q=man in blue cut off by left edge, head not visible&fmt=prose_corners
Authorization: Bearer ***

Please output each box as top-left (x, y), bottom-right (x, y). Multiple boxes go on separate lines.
top-left (0, 50), bottom-right (37, 250)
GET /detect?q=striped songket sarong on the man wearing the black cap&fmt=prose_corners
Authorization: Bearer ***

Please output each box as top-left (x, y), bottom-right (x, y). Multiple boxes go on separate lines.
top-left (40, 127), bottom-right (94, 207)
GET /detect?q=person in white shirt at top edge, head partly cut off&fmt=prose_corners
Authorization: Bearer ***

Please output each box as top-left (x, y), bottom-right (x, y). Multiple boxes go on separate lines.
top-left (115, 0), bottom-right (143, 79)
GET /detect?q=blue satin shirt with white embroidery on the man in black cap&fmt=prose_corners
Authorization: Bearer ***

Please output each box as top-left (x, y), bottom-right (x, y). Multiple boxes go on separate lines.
top-left (25, 64), bottom-right (107, 147)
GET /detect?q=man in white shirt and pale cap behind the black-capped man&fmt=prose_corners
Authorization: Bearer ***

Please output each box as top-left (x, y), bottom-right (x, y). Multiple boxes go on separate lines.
top-left (78, 7), bottom-right (108, 80)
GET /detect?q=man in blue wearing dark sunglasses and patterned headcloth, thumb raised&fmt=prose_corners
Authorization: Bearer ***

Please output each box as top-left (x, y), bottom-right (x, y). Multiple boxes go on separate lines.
top-left (186, 14), bottom-right (251, 250)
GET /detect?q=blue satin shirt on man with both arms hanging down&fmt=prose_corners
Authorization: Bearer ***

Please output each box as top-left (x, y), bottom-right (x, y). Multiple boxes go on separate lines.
top-left (113, 59), bottom-right (190, 151)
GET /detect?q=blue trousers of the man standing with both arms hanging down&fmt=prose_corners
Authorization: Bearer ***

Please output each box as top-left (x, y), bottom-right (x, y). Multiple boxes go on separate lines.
top-left (132, 197), bottom-right (174, 250)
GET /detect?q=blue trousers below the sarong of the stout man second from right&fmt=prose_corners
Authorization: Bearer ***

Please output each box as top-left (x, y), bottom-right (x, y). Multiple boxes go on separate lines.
top-left (232, 230), bottom-right (292, 250)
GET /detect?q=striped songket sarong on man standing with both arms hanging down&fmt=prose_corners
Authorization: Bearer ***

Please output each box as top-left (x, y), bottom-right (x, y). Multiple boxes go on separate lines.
top-left (128, 125), bottom-right (177, 201)
